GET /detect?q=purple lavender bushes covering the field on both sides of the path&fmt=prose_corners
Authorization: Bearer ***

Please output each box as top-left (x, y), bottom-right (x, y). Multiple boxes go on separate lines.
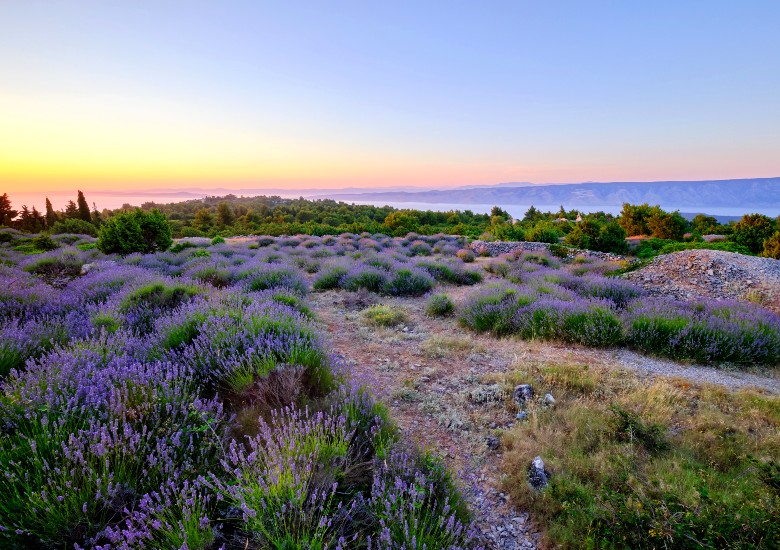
top-left (0, 230), bottom-right (780, 549)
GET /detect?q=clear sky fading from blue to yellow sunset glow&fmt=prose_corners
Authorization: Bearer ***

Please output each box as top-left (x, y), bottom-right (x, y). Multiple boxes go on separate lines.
top-left (0, 0), bottom-right (780, 193)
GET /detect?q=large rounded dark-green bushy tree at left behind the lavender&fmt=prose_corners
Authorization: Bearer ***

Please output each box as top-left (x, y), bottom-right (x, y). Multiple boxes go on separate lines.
top-left (97, 208), bottom-right (173, 254)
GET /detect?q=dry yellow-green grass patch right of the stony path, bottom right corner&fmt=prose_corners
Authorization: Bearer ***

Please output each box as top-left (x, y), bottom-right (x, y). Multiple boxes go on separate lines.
top-left (503, 364), bottom-right (780, 548)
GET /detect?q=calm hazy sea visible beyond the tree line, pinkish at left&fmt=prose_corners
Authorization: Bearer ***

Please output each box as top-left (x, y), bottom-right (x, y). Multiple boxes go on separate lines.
top-left (0, 190), bottom-right (780, 222)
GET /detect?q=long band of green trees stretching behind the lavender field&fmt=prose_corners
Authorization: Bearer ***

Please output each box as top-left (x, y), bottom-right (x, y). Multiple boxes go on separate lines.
top-left (0, 191), bottom-right (780, 258)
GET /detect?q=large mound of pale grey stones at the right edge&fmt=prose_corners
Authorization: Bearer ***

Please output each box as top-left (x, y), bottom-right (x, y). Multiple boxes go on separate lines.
top-left (624, 249), bottom-right (780, 312)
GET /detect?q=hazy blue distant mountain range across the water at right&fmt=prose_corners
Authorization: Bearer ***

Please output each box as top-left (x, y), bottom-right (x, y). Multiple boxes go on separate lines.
top-left (312, 177), bottom-right (780, 210)
